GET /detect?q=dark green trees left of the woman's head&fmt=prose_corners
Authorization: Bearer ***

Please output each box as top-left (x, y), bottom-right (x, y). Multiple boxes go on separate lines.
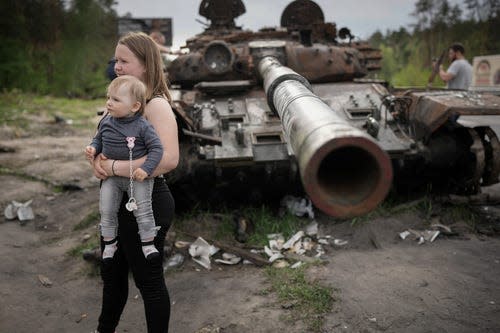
top-left (0, 0), bottom-right (117, 97)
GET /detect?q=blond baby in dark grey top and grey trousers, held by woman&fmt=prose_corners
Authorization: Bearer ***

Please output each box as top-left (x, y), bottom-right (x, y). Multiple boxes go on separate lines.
top-left (85, 75), bottom-right (163, 261)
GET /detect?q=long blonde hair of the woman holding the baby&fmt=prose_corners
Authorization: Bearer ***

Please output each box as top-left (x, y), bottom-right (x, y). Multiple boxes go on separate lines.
top-left (118, 32), bottom-right (172, 102)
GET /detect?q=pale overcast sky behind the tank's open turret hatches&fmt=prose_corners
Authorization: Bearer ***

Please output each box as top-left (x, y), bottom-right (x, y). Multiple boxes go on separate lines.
top-left (114, 0), bottom-right (455, 49)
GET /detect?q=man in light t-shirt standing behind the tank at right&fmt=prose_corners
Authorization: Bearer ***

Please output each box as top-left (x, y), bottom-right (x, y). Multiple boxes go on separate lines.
top-left (439, 43), bottom-right (472, 90)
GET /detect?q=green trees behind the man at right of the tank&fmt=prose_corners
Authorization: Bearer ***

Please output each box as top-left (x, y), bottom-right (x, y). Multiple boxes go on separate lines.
top-left (370, 0), bottom-right (500, 87)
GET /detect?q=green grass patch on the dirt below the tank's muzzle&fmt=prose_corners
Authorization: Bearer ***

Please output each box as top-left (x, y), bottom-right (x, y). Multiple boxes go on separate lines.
top-left (265, 265), bottom-right (334, 332)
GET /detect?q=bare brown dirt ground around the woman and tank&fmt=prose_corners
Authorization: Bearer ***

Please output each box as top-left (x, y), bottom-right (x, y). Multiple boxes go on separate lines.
top-left (0, 124), bottom-right (500, 333)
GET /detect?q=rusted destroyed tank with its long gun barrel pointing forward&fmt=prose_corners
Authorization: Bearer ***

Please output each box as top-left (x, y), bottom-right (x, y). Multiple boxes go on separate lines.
top-left (167, 0), bottom-right (500, 218)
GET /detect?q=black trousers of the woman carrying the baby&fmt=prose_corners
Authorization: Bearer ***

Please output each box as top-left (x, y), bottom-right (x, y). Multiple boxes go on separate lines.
top-left (97, 177), bottom-right (175, 333)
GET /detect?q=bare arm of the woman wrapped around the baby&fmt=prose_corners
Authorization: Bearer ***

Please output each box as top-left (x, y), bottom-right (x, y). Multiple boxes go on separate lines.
top-left (94, 98), bottom-right (179, 177)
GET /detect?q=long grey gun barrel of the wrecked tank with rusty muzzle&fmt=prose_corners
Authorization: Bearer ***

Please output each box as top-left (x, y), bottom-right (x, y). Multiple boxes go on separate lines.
top-left (258, 56), bottom-right (392, 218)
